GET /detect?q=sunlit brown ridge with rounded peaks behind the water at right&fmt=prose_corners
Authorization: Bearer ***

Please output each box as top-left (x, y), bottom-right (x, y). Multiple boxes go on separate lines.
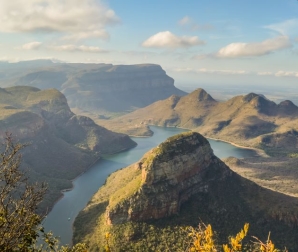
top-left (101, 89), bottom-right (298, 155)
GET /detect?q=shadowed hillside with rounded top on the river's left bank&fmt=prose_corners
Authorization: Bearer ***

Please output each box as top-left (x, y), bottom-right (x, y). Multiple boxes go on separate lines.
top-left (0, 86), bottom-right (136, 212)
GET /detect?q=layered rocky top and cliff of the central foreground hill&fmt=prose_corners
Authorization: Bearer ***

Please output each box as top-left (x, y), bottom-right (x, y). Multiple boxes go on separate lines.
top-left (106, 132), bottom-right (231, 224)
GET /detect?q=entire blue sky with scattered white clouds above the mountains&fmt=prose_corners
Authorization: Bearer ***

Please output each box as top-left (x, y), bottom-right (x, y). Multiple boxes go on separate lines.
top-left (0, 0), bottom-right (298, 87)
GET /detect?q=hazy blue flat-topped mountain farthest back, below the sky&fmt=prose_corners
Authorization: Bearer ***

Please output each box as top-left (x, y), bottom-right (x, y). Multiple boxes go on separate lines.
top-left (0, 61), bottom-right (186, 115)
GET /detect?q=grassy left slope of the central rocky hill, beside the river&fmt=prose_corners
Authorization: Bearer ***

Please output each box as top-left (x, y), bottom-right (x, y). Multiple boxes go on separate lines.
top-left (73, 165), bottom-right (141, 248)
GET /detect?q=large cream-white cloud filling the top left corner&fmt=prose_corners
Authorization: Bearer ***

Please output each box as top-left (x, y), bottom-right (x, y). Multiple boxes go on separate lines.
top-left (0, 0), bottom-right (119, 39)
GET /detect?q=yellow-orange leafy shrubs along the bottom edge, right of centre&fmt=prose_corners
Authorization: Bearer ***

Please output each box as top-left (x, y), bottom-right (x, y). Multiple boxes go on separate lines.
top-left (103, 223), bottom-right (287, 252)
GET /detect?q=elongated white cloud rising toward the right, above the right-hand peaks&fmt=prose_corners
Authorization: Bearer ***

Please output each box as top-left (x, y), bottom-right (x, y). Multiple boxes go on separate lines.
top-left (216, 36), bottom-right (292, 58)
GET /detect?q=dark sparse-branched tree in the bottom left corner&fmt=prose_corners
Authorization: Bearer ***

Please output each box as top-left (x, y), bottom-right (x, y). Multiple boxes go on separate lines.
top-left (0, 134), bottom-right (86, 252)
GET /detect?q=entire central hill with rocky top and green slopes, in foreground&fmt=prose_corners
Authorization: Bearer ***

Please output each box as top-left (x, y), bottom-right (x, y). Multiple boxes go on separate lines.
top-left (74, 132), bottom-right (298, 251)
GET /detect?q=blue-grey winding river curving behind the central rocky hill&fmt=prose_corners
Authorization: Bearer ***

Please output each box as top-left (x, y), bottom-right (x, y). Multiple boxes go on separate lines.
top-left (44, 127), bottom-right (255, 245)
